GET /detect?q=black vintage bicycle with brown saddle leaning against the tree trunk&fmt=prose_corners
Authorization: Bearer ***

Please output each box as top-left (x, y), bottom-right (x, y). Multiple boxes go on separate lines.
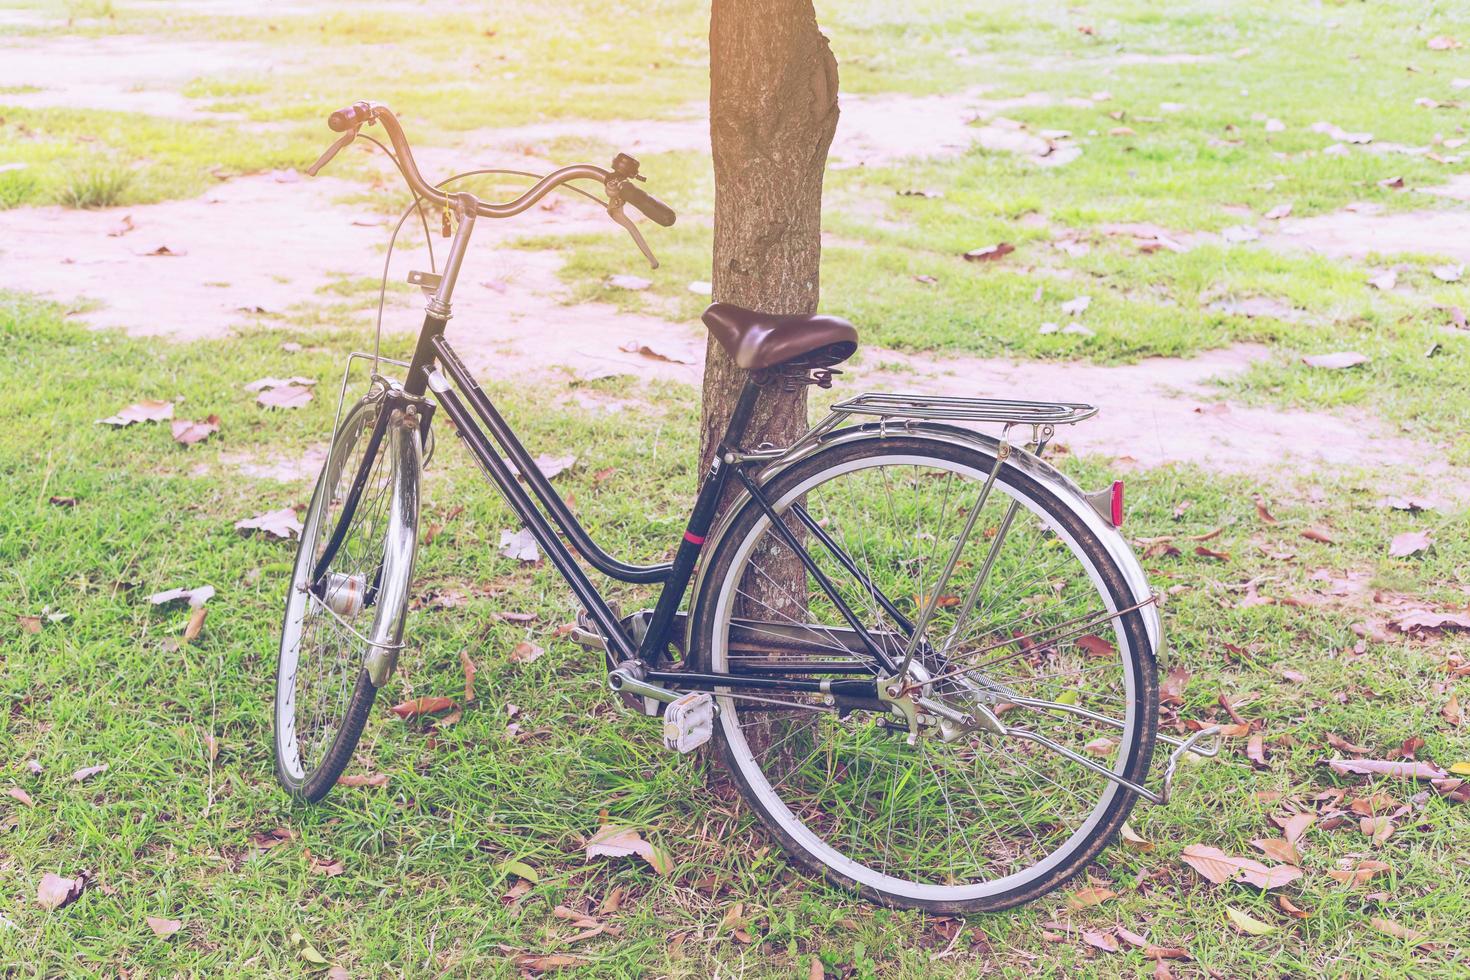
top-left (275, 103), bottom-right (1219, 912)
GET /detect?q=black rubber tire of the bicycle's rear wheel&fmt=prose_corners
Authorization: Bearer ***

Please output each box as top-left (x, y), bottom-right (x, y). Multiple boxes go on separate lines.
top-left (689, 436), bottom-right (1158, 914)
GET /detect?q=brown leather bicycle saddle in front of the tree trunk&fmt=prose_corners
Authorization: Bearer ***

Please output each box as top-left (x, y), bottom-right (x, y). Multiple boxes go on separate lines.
top-left (704, 303), bottom-right (857, 370)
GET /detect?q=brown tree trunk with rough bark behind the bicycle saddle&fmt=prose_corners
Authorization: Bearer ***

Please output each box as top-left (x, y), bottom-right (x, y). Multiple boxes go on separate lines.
top-left (700, 0), bottom-right (838, 472)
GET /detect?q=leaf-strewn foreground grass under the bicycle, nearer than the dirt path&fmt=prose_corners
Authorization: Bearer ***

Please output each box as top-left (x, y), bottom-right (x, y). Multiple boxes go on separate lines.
top-left (0, 297), bottom-right (1470, 976)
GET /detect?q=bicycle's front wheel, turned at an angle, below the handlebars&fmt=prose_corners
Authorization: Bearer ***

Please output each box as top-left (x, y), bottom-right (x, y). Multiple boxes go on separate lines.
top-left (275, 385), bottom-right (422, 802)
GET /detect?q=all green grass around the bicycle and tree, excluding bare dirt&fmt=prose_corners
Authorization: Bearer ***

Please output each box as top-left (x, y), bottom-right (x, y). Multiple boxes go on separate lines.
top-left (0, 0), bottom-right (1470, 977)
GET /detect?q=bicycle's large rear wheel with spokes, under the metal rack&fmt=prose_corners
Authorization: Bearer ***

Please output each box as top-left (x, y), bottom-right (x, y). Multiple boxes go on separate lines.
top-left (691, 436), bottom-right (1158, 912)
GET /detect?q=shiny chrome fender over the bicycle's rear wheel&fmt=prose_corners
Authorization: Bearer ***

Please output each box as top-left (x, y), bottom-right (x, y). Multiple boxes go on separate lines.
top-left (685, 422), bottom-right (1164, 658)
